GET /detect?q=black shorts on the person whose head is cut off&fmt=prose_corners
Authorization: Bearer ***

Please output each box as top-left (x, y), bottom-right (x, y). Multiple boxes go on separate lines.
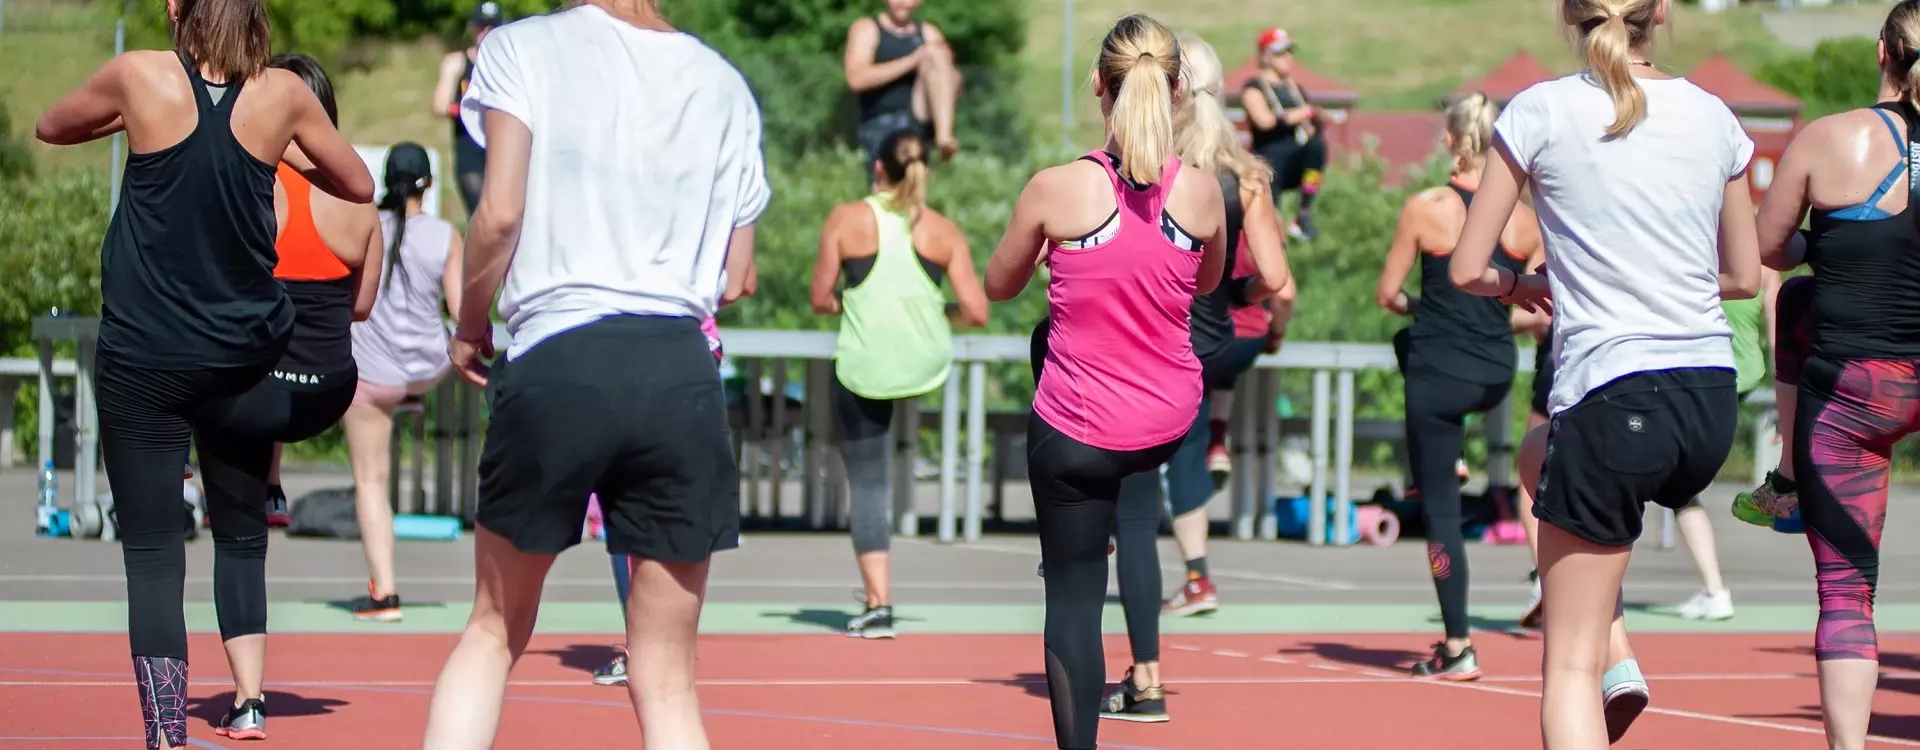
top-left (478, 315), bottom-right (739, 562)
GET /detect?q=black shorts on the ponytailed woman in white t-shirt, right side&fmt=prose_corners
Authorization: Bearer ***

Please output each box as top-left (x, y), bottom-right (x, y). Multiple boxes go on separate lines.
top-left (1534, 368), bottom-right (1740, 547)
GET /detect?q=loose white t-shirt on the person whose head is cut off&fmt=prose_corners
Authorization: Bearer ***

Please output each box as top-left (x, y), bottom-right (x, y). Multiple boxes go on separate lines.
top-left (461, 6), bottom-right (770, 359)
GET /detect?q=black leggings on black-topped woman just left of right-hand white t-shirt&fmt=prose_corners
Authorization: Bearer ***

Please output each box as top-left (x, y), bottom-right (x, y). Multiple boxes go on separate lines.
top-left (1405, 366), bottom-right (1513, 639)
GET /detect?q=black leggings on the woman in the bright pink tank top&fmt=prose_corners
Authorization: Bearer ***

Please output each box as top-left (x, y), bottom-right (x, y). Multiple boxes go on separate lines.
top-left (1027, 416), bottom-right (1179, 750)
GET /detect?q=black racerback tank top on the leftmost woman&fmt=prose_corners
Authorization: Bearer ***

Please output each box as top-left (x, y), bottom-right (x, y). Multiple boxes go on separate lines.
top-left (100, 54), bottom-right (294, 370)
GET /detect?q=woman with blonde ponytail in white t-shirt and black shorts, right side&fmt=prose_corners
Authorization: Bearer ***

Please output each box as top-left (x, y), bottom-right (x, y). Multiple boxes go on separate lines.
top-left (1448, 0), bottom-right (1761, 750)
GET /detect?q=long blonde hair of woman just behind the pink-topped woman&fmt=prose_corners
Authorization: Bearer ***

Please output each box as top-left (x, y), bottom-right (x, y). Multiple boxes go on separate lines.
top-left (1173, 35), bottom-right (1273, 186)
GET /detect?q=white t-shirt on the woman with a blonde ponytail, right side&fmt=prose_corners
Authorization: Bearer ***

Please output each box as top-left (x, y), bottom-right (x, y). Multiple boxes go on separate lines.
top-left (1494, 73), bottom-right (1753, 414)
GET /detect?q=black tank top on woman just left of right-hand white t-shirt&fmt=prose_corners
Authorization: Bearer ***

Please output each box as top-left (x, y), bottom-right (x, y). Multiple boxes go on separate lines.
top-left (1407, 182), bottom-right (1526, 386)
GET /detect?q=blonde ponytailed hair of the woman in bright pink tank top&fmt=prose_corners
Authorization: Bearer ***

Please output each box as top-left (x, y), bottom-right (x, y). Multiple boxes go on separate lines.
top-left (1098, 13), bottom-right (1181, 184)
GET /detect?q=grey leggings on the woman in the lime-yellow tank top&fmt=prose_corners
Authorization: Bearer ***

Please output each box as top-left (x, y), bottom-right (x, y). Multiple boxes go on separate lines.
top-left (833, 378), bottom-right (897, 554)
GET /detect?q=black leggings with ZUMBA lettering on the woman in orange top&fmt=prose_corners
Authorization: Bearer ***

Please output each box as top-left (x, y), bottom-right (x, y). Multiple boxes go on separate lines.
top-left (200, 364), bottom-right (359, 641)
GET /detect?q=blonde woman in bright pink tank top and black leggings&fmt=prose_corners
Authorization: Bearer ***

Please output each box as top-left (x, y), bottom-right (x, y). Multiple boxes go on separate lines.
top-left (987, 15), bottom-right (1227, 750)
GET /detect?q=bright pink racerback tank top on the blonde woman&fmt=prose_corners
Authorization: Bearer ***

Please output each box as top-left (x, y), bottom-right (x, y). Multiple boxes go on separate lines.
top-left (1033, 152), bottom-right (1202, 451)
